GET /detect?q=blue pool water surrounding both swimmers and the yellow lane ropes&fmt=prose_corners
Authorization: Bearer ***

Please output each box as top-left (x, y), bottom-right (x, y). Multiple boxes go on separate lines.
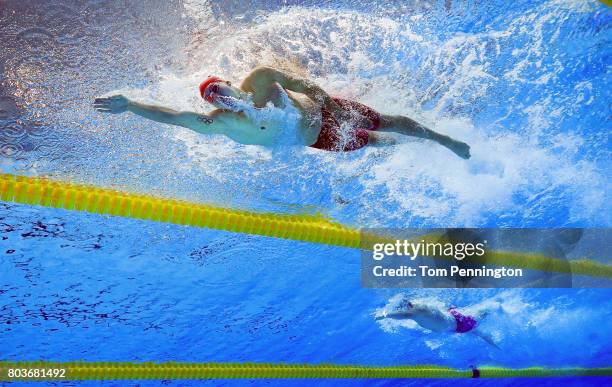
top-left (0, 0), bottom-right (612, 385)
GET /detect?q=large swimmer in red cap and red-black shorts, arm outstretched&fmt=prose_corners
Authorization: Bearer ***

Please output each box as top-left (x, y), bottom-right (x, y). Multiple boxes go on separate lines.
top-left (94, 67), bottom-right (470, 159)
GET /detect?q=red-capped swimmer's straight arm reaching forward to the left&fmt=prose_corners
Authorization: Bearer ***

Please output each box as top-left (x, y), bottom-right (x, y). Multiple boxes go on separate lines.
top-left (94, 95), bottom-right (235, 134)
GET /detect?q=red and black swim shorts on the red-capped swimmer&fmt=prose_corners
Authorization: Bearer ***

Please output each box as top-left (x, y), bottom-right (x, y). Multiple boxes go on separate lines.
top-left (311, 97), bottom-right (380, 152)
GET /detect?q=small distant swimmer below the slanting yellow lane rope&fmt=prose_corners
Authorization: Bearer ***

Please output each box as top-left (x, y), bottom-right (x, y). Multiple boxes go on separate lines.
top-left (376, 298), bottom-right (499, 348)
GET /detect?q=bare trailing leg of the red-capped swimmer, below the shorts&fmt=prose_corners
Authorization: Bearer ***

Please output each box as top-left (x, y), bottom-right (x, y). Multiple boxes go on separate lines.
top-left (378, 114), bottom-right (470, 159)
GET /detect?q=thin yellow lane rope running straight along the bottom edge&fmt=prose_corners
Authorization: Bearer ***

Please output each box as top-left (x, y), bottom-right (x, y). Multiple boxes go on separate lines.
top-left (0, 361), bottom-right (612, 381)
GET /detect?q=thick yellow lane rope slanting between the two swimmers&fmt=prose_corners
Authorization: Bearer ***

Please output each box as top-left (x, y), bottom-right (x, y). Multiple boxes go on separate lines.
top-left (0, 174), bottom-right (612, 278)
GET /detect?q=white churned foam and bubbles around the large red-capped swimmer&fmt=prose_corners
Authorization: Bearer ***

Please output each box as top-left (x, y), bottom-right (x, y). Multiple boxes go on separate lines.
top-left (104, 2), bottom-right (608, 226)
